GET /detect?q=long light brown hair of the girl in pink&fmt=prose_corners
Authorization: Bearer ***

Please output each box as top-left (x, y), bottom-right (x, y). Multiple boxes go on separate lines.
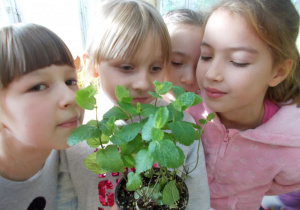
top-left (206, 0), bottom-right (300, 104)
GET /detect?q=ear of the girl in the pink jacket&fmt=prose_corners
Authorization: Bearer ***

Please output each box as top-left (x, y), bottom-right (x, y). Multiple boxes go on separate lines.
top-left (269, 59), bottom-right (294, 87)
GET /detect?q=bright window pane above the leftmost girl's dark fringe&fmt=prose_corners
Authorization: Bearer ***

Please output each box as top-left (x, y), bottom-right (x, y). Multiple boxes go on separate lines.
top-left (0, 0), bottom-right (84, 57)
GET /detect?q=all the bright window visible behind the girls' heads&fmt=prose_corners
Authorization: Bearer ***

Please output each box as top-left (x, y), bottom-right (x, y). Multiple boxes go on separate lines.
top-left (0, 0), bottom-right (300, 55)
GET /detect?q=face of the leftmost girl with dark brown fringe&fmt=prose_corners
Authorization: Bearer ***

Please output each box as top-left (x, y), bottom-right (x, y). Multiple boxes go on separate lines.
top-left (0, 65), bottom-right (83, 151)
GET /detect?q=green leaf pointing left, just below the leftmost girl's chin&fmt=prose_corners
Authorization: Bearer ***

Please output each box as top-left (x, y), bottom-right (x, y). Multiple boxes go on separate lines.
top-left (67, 124), bottom-right (101, 146)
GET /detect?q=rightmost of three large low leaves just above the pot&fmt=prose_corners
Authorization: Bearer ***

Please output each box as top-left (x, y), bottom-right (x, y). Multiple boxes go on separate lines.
top-left (148, 139), bottom-right (183, 168)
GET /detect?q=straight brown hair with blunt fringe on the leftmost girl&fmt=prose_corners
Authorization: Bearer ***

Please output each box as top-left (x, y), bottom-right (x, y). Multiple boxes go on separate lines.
top-left (0, 23), bottom-right (75, 89)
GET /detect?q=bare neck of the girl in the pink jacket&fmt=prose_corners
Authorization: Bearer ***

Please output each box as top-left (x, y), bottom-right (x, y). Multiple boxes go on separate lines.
top-left (218, 101), bottom-right (264, 131)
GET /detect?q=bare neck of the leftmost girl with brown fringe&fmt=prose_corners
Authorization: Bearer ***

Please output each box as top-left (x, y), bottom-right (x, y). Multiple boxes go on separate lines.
top-left (0, 131), bottom-right (52, 181)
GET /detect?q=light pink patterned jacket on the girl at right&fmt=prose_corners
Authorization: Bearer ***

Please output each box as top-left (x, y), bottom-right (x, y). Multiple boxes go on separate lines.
top-left (188, 95), bottom-right (300, 210)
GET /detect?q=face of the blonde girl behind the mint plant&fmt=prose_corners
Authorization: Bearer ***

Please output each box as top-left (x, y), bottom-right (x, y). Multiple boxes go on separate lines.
top-left (96, 36), bottom-right (166, 104)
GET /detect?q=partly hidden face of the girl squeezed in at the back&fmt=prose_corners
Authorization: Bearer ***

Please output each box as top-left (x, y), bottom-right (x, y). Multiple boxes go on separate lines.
top-left (167, 25), bottom-right (203, 92)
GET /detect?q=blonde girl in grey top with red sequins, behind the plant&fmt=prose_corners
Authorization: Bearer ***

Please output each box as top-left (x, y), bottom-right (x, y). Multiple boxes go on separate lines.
top-left (67, 0), bottom-right (210, 209)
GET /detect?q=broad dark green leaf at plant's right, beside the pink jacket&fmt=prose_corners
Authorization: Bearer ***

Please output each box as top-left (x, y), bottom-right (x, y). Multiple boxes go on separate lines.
top-left (169, 121), bottom-right (196, 146)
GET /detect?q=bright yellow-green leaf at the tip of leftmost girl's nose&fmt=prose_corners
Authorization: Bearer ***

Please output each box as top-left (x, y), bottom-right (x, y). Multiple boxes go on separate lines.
top-left (75, 84), bottom-right (97, 110)
